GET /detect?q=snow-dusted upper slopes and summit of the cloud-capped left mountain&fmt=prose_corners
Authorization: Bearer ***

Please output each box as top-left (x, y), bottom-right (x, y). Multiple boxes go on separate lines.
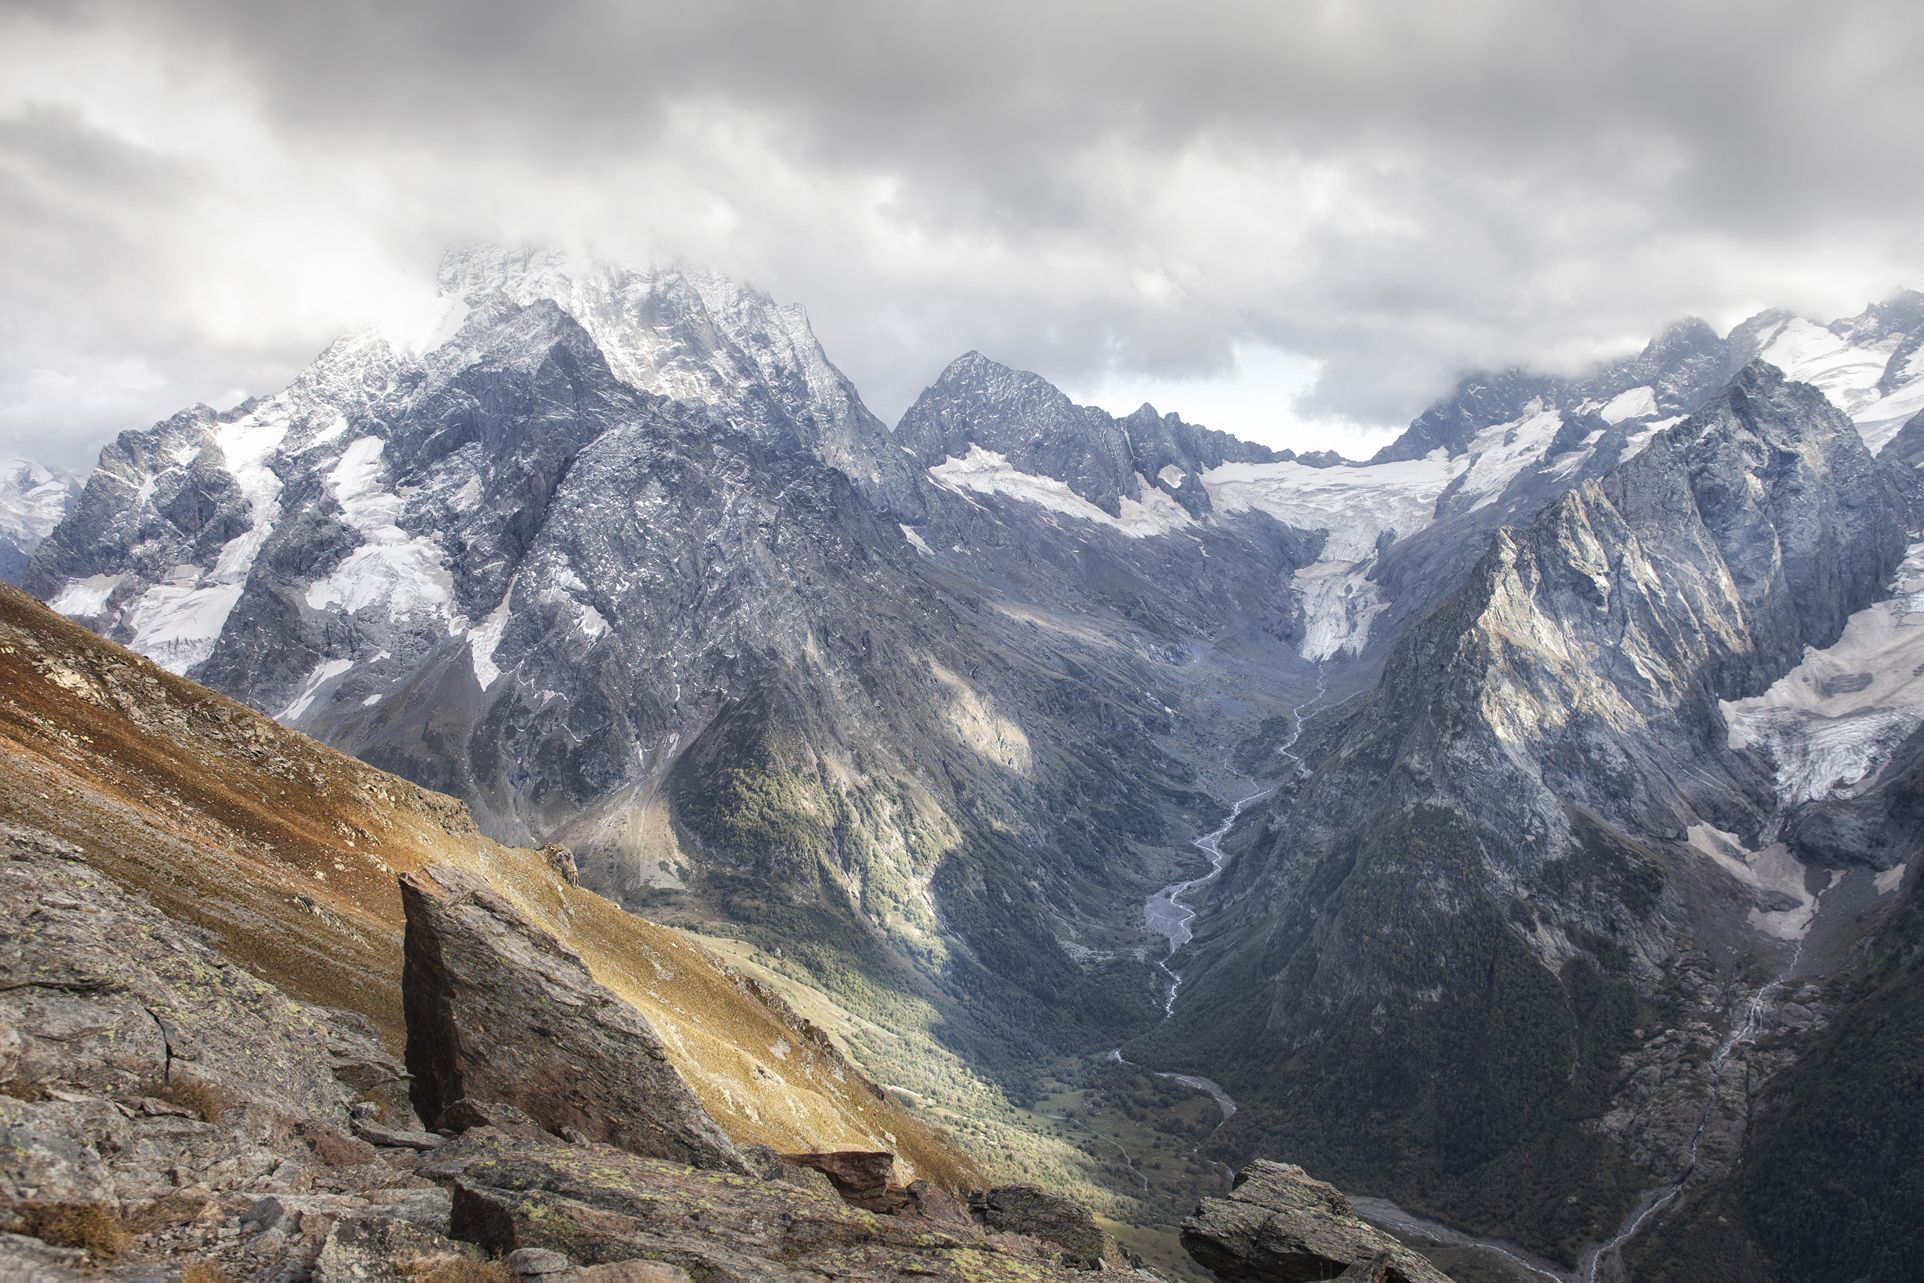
top-left (25, 239), bottom-right (916, 689)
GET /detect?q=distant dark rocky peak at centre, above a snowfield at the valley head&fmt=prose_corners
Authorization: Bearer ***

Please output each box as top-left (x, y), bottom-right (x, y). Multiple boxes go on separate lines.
top-left (897, 352), bottom-right (1293, 517)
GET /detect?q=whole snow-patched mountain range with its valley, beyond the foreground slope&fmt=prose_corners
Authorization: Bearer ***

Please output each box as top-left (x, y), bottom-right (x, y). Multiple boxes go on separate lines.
top-left (8, 248), bottom-right (1924, 1279)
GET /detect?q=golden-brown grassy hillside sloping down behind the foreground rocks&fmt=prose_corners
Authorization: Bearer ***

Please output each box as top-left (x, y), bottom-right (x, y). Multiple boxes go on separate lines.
top-left (0, 585), bottom-right (977, 1185)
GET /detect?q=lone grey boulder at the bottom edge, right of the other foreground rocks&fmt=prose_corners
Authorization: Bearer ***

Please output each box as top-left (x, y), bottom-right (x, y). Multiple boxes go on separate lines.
top-left (1183, 1160), bottom-right (1451, 1283)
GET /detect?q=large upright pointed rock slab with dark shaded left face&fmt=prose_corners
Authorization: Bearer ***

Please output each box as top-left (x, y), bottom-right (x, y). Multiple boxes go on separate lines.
top-left (402, 864), bottom-right (750, 1173)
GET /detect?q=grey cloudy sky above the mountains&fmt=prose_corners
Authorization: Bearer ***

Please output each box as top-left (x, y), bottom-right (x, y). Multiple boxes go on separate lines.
top-left (0, 0), bottom-right (1924, 464)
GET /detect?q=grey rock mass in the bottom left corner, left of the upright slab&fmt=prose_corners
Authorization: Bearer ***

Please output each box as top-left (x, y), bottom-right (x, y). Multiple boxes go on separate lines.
top-left (0, 825), bottom-right (477, 1281)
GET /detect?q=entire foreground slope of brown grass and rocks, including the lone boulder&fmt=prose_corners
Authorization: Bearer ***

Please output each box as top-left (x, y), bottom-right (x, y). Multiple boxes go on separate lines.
top-left (0, 591), bottom-right (1443, 1283)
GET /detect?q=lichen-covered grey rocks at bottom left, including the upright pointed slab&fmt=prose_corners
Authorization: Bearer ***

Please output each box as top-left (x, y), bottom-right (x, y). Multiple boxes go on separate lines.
top-left (0, 827), bottom-right (1139, 1283)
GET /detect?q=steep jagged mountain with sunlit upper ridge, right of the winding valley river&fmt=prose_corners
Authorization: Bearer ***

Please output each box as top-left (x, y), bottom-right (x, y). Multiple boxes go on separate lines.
top-left (1170, 365), bottom-right (1909, 1243)
